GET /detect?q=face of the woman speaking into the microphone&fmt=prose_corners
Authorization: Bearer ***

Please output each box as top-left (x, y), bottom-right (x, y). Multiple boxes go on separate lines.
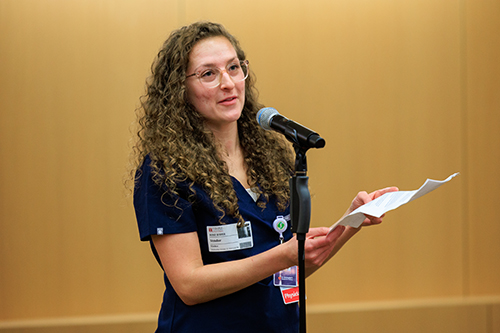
top-left (186, 36), bottom-right (245, 130)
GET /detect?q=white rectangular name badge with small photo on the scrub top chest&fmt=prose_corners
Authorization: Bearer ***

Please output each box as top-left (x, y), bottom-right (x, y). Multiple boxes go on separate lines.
top-left (207, 221), bottom-right (253, 252)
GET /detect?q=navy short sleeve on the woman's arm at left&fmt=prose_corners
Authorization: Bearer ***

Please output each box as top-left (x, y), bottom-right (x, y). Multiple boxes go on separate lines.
top-left (134, 158), bottom-right (197, 241)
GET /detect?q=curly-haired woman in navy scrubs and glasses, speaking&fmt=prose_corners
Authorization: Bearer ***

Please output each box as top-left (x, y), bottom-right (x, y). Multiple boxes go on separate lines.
top-left (134, 22), bottom-right (394, 333)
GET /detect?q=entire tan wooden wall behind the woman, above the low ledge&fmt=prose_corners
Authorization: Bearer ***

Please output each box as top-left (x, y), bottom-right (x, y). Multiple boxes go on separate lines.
top-left (0, 0), bottom-right (500, 332)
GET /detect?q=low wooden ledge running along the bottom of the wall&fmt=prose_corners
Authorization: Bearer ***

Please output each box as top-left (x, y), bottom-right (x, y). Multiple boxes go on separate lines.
top-left (0, 297), bottom-right (500, 333)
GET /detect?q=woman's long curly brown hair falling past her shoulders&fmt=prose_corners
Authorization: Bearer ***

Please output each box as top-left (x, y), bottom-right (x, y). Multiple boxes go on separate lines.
top-left (132, 22), bottom-right (293, 223)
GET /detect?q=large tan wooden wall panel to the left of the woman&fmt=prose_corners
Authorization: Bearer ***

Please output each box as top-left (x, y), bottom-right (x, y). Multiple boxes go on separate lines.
top-left (0, 0), bottom-right (177, 319)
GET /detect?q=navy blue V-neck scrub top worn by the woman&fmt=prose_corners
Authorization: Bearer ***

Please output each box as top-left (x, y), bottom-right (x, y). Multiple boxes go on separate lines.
top-left (134, 158), bottom-right (299, 333)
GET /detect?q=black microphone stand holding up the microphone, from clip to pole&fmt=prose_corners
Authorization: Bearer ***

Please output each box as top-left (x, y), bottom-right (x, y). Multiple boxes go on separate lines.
top-left (290, 144), bottom-right (311, 333)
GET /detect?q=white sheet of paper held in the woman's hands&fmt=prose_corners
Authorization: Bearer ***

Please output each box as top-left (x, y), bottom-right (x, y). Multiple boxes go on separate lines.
top-left (330, 172), bottom-right (459, 231)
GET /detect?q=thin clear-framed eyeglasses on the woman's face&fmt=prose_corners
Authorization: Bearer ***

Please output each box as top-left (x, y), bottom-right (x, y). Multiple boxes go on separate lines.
top-left (186, 60), bottom-right (248, 88)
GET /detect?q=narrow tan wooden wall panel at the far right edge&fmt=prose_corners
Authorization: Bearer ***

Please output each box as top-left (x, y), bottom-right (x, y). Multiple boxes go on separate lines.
top-left (465, 0), bottom-right (500, 295)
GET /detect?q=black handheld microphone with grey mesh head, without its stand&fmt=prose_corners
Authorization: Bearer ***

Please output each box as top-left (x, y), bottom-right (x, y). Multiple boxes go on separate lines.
top-left (257, 107), bottom-right (326, 149)
